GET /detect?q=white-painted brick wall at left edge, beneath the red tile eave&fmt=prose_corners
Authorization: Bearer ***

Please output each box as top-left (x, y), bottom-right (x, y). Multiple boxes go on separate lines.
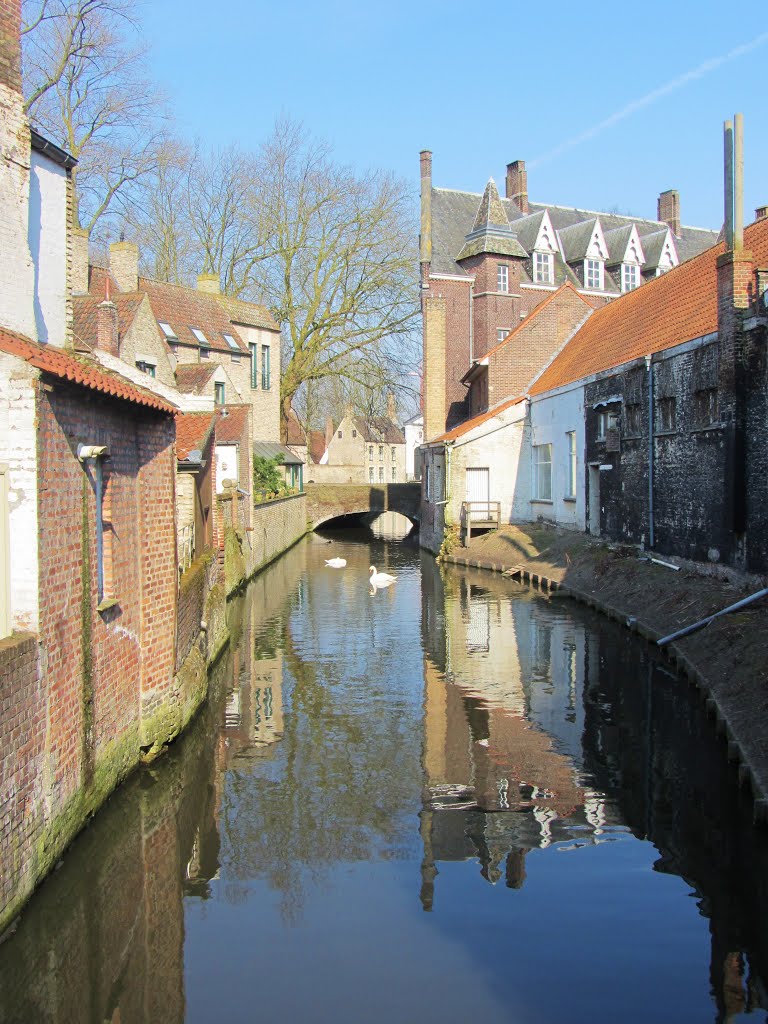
top-left (0, 352), bottom-right (39, 632)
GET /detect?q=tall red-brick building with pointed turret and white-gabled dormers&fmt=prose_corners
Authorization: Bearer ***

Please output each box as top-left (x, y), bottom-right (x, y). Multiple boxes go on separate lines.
top-left (420, 151), bottom-right (717, 440)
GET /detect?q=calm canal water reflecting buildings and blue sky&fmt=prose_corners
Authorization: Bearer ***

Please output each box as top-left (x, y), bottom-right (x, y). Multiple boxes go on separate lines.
top-left (0, 531), bottom-right (768, 1024)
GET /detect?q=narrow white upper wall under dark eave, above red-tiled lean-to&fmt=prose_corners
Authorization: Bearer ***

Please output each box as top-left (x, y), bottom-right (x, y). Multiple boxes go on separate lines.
top-left (29, 151), bottom-right (67, 346)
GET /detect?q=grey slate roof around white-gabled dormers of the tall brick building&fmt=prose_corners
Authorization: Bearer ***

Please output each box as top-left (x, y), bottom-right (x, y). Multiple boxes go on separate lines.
top-left (430, 187), bottom-right (718, 276)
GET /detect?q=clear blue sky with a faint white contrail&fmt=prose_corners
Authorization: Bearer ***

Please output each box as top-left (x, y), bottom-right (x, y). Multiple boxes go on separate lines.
top-left (142, 0), bottom-right (768, 227)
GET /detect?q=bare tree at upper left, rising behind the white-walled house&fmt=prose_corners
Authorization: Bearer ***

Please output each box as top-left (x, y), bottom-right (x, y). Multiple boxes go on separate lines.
top-left (24, 0), bottom-right (166, 229)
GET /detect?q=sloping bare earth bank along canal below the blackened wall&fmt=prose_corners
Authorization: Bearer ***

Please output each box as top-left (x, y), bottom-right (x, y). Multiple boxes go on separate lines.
top-left (443, 524), bottom-right (768, 824)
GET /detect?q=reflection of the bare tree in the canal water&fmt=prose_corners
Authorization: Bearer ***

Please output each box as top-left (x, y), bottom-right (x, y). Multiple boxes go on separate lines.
top-left (217, 606), bottom-right (419, 921)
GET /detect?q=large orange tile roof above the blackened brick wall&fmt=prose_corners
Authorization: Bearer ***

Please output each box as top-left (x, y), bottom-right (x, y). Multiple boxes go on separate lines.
top-left (530, 220), bottom-right (768, 394)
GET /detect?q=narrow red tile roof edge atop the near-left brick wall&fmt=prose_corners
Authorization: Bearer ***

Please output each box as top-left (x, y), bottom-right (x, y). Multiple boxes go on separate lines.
top-left (0, 328), bottom-right (176, 414)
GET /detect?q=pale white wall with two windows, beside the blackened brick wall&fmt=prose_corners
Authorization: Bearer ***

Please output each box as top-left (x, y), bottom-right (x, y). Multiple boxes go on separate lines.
top-left (522, 385), bottom-right (587, 529)
